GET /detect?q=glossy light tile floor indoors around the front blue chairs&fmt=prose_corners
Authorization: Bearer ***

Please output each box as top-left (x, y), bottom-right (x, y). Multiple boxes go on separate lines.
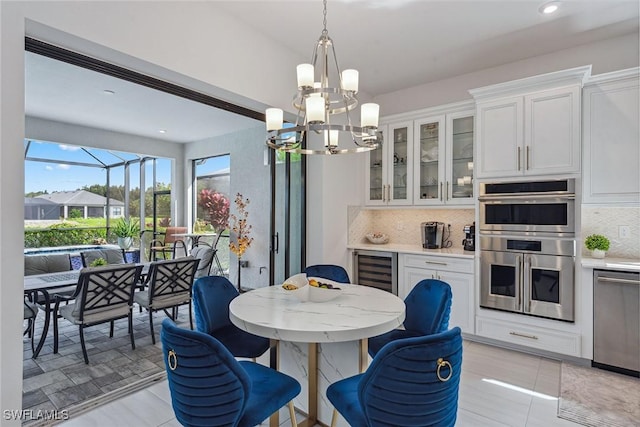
top-left (63, 341), bottom-right (578, 427)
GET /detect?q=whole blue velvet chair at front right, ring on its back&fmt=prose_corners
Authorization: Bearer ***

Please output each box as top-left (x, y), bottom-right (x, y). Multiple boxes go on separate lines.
top-left (327, 327), bottom-right (462, 427)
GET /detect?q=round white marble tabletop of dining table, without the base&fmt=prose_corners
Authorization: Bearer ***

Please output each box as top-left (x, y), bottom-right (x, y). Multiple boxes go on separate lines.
top-left (229, 284), bottom-right (405, 343)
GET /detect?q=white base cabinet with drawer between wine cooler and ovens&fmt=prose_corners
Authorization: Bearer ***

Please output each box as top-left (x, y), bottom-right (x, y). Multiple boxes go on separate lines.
top-left (398, 254), bottom-right (475, 334)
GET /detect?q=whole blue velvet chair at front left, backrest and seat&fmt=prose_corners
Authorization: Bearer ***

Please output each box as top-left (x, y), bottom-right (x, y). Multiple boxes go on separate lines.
top-left (160, 318), bottom-right (301, 427)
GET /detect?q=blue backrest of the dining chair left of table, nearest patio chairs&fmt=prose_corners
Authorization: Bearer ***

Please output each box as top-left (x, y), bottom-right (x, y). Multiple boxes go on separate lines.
top-left (193, 276), bottom-right (239, 334)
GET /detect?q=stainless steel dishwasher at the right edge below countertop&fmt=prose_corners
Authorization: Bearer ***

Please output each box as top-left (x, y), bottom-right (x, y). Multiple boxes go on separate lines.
top-left (593, 270), bottom-right (640, 377)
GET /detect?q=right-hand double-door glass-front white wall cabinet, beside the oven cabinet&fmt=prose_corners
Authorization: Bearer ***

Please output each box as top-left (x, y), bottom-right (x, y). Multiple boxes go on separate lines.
top-left (413, 110), bottom-right (474, 205)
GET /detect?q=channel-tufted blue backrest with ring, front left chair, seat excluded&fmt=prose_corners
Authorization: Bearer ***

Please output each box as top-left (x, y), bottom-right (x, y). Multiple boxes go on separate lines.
top-left (160, 319), bottom-right (251, 426)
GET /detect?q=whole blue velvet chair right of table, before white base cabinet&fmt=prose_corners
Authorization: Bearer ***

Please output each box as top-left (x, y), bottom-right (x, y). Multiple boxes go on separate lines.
top-left (369, 279), bottom-right (452, 357)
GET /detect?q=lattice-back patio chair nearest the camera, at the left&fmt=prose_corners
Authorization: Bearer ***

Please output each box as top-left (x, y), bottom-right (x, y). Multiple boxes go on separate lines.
top-left (53, 264), bottom-right (142, 364)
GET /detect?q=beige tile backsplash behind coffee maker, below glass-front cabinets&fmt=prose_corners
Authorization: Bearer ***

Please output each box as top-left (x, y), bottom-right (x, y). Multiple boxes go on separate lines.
top-left (348, 206), bottom-right (475, 248)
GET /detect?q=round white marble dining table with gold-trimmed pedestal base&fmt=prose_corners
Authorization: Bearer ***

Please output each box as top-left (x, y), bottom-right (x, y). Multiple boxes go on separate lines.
top-left (229, 284), bottom-right (405, 427)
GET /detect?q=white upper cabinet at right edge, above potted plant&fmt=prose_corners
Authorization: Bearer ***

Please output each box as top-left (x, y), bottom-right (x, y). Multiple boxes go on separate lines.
top-left (582, 68), bottom-right (640, 203)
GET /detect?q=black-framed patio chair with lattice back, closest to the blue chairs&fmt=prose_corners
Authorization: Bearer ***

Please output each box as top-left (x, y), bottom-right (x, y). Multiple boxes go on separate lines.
top-left (133, 256), bottom-right (200, 344)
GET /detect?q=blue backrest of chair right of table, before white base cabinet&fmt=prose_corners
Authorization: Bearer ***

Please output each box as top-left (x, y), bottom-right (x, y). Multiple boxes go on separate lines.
top-left (404, 279), bottom-right (452, 335)
